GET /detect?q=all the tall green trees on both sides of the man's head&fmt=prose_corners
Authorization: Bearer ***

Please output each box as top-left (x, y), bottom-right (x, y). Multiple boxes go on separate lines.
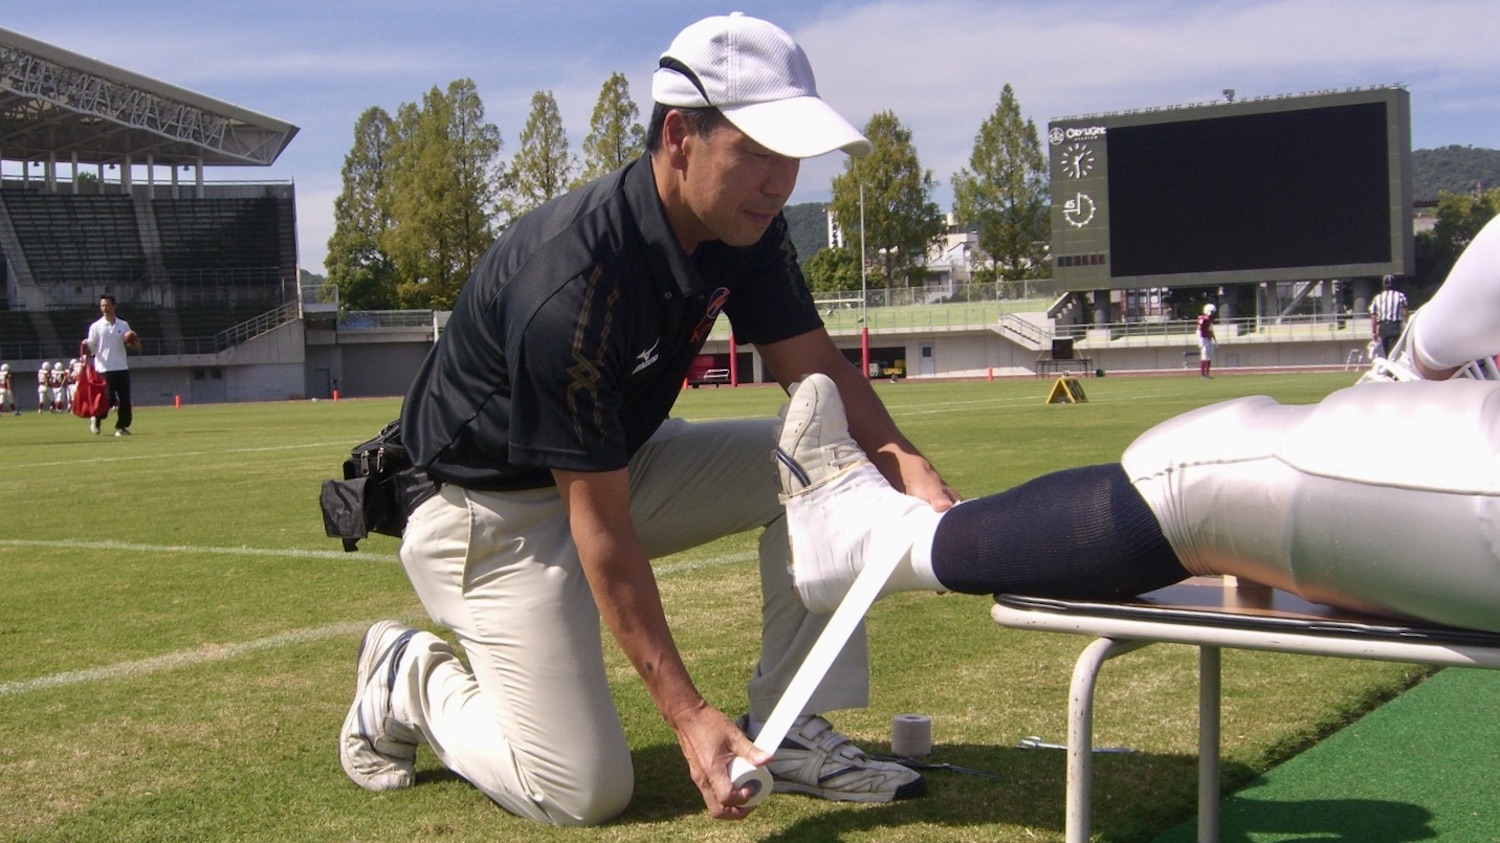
top-left (326, 74), bottom-right (1050, 311)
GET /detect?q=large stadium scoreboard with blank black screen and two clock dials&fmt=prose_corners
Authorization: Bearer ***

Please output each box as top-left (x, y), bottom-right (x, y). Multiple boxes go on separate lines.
top-left (1047, 87), bottom-right (1413, 291)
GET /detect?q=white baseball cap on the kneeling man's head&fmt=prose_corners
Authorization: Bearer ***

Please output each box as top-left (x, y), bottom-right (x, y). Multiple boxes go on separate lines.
top-left (651, 12), bottom-right (873, 158)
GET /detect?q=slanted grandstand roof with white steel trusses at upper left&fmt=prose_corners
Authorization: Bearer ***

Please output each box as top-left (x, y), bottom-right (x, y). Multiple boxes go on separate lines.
top-left (0, 29), bottom-right (297, 167)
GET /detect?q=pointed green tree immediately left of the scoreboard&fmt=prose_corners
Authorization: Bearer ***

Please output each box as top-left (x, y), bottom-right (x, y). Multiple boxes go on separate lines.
top-left (953, 84), bottom-right (1052, 281)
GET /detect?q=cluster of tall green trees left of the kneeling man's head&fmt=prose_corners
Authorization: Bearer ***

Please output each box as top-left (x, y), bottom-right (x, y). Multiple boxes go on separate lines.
top-left (326, 74), bottom-right (645, 311)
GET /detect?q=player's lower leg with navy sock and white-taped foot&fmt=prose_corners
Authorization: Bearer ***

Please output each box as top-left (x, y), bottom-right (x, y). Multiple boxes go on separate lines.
top-left (779, 372), bottom-right (1187, 611)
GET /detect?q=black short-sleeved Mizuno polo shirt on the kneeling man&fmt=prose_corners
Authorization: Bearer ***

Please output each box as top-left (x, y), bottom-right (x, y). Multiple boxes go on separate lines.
top-left (401, 156), bottom-right (822, 491)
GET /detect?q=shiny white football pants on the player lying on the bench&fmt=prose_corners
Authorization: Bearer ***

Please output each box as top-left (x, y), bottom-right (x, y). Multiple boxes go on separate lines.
top-left (1121, 380), bottom-right (1500, 632)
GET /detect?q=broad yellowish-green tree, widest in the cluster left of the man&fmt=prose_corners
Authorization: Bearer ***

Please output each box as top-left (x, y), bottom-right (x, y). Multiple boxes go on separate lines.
top-left (380, 80), bottom-right (503, 309)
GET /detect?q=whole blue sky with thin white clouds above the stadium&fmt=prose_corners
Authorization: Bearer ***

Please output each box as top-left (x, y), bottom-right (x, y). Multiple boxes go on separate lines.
top-left (11, 0), bottom-right (1500, 273)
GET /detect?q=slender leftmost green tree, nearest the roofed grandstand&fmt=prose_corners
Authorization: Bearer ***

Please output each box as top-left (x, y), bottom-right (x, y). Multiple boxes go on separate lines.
top-left (324, 107), bottom-right (396, 311)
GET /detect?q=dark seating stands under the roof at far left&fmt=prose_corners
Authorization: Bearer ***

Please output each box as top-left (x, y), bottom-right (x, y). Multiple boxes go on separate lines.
top-left (0, 186), bottom-right (296, 360)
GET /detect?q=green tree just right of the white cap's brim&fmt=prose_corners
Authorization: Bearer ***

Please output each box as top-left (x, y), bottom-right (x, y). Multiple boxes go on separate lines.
top-left (831, 111), bottom-right (944, 287)
